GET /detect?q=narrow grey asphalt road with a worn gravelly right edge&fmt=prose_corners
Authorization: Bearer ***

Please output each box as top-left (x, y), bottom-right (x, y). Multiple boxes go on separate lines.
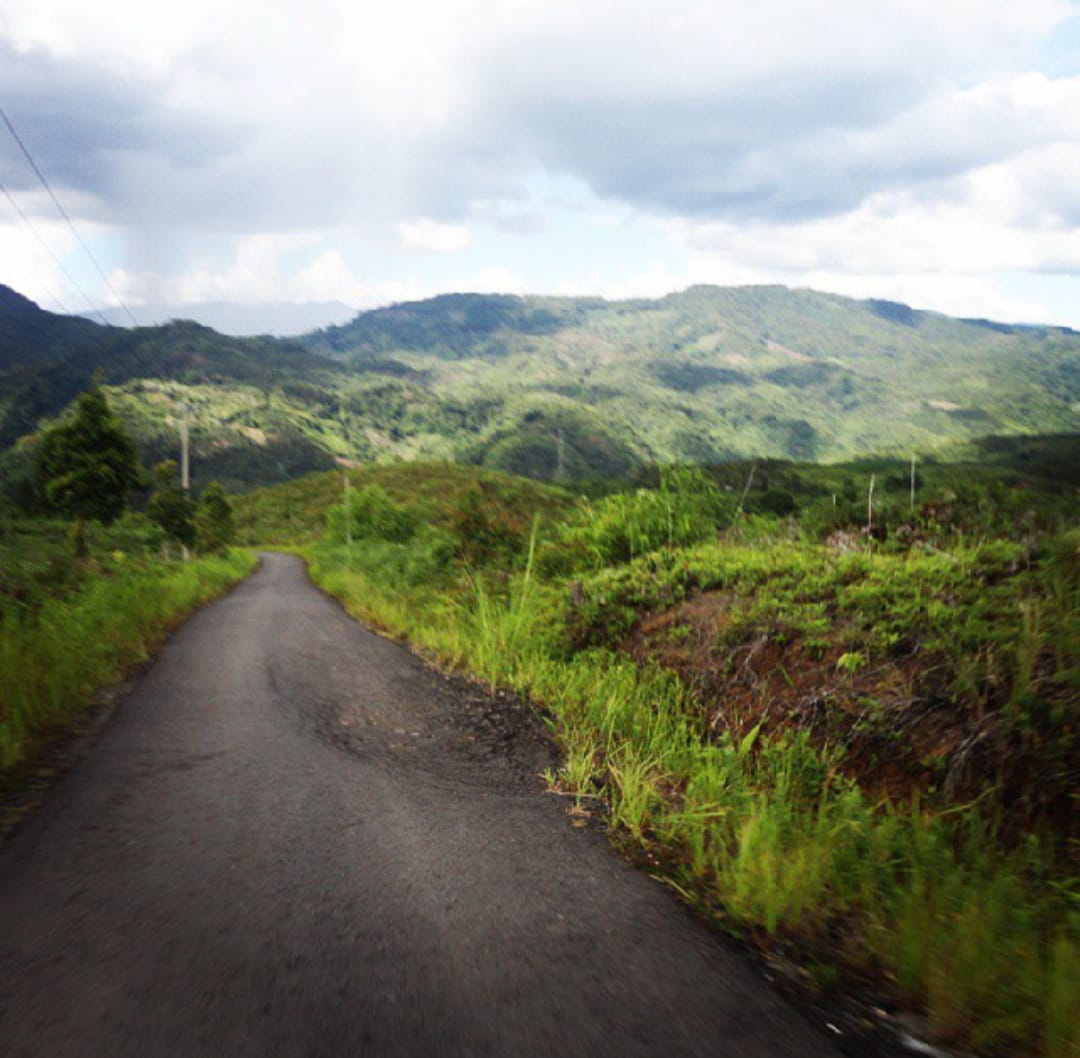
top-left (0, 555), bottom-right (855, 1058)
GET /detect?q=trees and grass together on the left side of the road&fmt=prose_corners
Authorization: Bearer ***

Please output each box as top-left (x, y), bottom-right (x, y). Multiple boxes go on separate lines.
top-left (0, 383), bottom-right (254, 786)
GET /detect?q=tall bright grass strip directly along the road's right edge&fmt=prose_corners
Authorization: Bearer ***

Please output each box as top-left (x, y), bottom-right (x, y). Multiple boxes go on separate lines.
top-left (311, 551), bottom-right (1080, 1058)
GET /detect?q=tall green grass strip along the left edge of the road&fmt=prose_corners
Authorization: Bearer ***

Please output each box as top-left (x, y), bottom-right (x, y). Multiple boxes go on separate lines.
top-left (0, 552), bottom-right (256, 769)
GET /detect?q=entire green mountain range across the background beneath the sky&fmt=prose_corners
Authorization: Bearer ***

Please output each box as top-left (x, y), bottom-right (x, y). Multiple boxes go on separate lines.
top-left (0, 286), bottom-right (1080, 487)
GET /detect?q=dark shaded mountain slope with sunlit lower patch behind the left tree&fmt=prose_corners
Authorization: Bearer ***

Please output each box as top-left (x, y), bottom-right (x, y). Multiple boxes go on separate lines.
top-left (0, 287), bottom-right (347, 487)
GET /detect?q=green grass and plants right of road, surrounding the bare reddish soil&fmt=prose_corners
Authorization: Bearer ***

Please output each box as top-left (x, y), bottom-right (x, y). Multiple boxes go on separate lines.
top-left (285, 466), bottom-right (1080, 1058)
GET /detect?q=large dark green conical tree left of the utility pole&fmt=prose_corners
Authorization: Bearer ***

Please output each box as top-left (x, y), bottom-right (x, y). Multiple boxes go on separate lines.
top-left (35, 382), bottom-right (143, 523)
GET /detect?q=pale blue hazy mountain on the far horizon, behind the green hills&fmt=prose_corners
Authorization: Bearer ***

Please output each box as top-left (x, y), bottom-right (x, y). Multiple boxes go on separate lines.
top-left (87, 301), bottom-right (356, 337)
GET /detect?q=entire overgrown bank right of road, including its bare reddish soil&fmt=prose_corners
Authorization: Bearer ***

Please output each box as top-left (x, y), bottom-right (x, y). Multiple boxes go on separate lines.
top-left (238, 438), bottom-right (1080, 1058)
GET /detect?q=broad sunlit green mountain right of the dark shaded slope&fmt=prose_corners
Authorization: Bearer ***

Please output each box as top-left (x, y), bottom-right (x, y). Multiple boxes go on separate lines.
top-left (305, 287), bottom-right (1080, 476)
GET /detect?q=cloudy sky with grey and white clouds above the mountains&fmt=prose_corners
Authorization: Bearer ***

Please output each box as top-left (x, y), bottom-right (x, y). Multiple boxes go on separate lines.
top-left (0, 0), bottom-right (1080, 327)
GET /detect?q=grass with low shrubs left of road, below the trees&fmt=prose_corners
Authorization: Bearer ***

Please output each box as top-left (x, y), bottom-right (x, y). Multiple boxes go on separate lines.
top-left (0, 520), bottom-right (256, 773)
